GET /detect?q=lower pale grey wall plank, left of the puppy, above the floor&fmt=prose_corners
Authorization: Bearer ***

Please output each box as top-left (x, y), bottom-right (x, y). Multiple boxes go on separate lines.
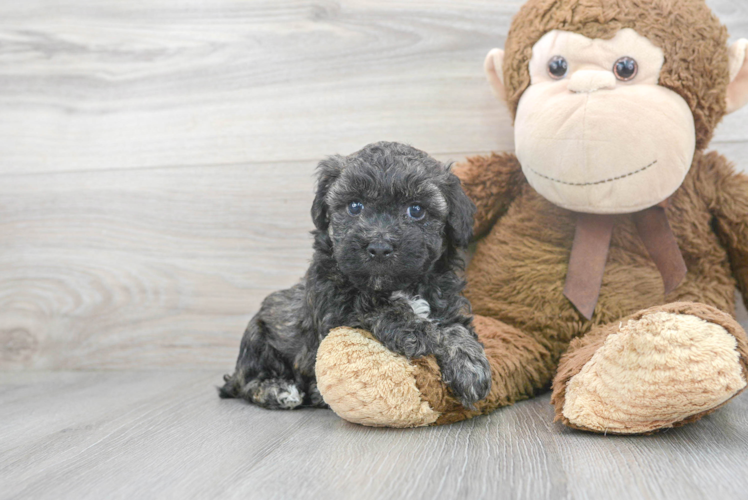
top-left (0, 162), bottom-right (315, 369)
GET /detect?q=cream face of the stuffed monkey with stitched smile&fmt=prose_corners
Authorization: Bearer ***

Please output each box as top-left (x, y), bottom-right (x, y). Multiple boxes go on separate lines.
top-left (515, 29), bottom-right (696, 213)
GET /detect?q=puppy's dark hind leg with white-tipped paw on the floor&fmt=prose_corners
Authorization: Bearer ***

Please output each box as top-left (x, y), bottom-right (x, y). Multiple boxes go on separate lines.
top-left (218, 314), bottom-right (304, 410)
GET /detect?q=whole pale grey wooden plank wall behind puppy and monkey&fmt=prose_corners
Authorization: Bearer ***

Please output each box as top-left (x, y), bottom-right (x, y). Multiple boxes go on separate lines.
top-left (0, 0), bottom-right (748, 369)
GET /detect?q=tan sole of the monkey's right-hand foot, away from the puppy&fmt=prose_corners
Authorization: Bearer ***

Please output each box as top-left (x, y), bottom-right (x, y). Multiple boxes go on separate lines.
top-left (563, 312), bottom-right (746, 434)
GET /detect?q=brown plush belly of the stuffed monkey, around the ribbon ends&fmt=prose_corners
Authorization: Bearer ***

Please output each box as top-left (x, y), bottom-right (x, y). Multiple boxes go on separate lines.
top-left (465, 199), bottom-right (734, 354)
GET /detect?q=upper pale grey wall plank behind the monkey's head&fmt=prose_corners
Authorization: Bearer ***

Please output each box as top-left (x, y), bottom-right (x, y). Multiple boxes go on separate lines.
top-left (0, 0), bottom-right (748, 174)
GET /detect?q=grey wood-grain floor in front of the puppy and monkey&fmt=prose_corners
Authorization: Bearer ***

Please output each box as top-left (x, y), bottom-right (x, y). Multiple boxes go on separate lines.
top-left (0, 371), bottom-right (748, 500)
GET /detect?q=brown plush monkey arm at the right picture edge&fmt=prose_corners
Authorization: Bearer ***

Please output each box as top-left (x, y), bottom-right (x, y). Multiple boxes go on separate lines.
top-left (703, 153), bottom-right (748, 306)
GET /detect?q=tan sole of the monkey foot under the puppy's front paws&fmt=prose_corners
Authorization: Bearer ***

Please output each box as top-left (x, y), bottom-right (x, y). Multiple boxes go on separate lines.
top-left (316, 327), bottom-right (440, 427)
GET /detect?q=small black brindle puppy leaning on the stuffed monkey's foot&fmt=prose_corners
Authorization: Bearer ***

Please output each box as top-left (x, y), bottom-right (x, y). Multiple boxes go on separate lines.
top-left (220, 142), bottom-right (491, 409)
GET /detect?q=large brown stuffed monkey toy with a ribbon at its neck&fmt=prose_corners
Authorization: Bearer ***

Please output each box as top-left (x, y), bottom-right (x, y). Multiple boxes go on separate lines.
top-left (316, 0), bottom-right (748, 434)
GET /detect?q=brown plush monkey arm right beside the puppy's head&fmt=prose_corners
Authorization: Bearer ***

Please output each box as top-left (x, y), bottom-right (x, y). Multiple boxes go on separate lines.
top-left (452, 153), bottom-right (527, 239)
